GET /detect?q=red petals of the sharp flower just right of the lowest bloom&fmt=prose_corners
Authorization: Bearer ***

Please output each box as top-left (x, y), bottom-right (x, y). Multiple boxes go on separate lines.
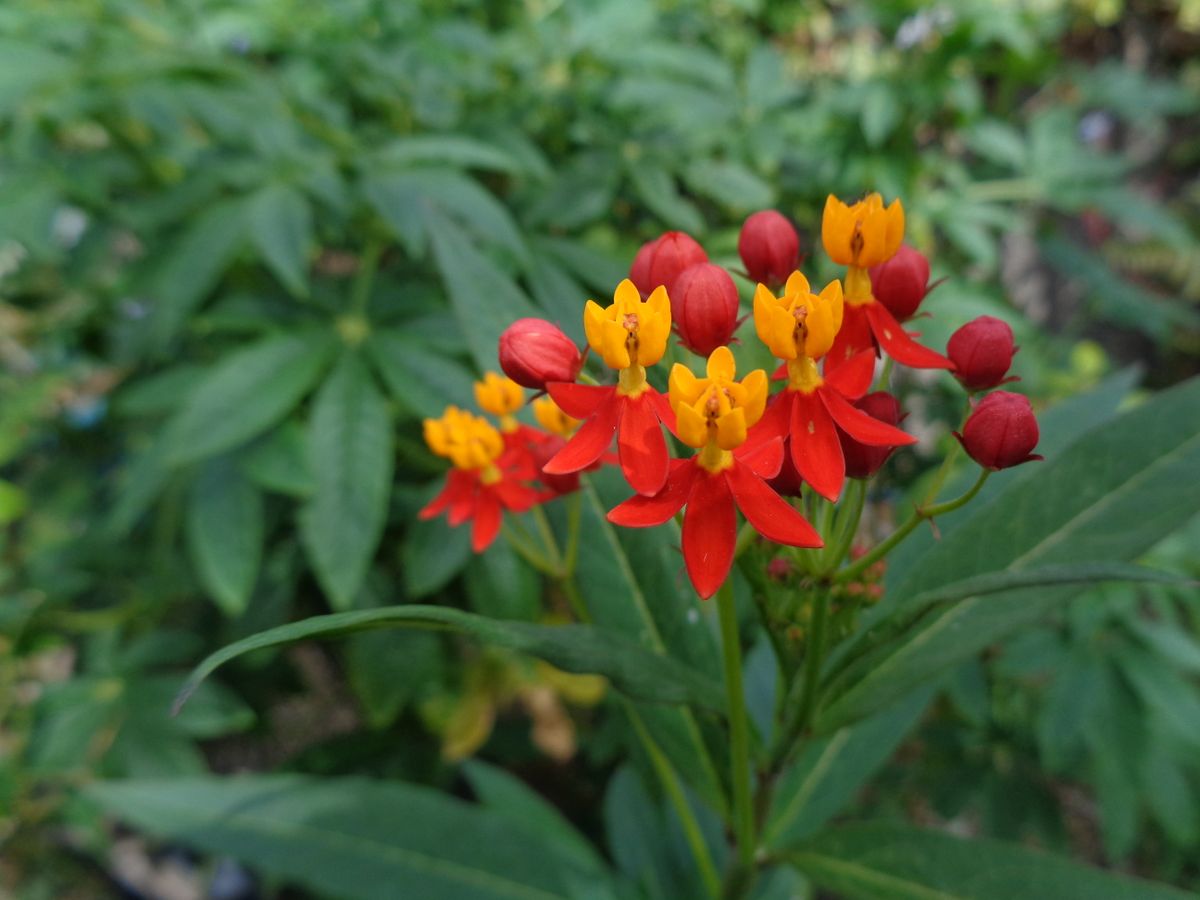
top-left (750, 353), bottom-right (917, 500)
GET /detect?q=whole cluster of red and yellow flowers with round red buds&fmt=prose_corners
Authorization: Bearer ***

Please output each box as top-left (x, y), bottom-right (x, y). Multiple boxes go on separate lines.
top-left (421, 193), bottom-right (1038, 598)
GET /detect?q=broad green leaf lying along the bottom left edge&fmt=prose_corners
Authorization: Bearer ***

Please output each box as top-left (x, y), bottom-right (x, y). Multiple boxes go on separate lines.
top-left (86, 775), bottom-right (580, 900)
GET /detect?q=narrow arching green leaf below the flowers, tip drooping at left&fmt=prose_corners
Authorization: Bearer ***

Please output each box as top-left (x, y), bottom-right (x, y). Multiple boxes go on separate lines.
top-left (176, 605), bottom-right (724, 713)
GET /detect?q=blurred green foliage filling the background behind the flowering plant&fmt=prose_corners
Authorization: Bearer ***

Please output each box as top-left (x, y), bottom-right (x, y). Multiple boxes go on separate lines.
top-left (0, 0), bottom-right (1200, 895)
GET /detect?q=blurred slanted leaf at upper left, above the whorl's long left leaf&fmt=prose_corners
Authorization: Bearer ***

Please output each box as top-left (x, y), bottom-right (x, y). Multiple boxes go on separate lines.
top-left (146, 198), bottom-right (247, 349)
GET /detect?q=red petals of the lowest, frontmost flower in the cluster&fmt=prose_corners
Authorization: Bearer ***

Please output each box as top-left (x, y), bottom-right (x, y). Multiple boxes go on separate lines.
top-left (608, 438), bottom-right (824, 599)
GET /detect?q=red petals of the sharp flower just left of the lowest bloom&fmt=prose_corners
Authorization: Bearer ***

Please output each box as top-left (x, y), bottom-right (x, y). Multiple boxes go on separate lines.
top-left (541, 382), bottom-right (674, 494)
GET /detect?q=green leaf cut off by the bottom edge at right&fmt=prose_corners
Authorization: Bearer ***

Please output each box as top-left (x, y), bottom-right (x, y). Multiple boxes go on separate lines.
top-left (786, 824), bottom-right (1192, 900)
